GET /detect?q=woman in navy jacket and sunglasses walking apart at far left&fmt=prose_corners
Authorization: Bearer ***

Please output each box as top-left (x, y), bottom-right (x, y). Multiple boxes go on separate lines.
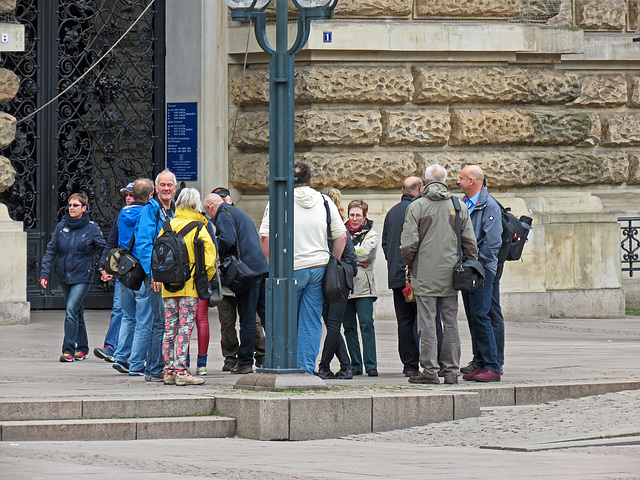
top-left (40, 193), bottom-right (105, 362)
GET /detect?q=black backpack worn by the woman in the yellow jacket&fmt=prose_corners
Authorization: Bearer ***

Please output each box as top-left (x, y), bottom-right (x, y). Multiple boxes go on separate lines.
top-left (151, 220), bottom-right (204, 292)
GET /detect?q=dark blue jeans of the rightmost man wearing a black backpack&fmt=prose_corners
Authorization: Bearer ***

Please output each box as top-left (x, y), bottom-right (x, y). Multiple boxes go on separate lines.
top-left (462, 270), bottom-right (500, 373)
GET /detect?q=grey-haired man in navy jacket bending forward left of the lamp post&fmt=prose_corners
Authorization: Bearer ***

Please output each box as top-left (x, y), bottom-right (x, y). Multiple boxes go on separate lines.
top-left (204, 193), bottom-right (269, 374)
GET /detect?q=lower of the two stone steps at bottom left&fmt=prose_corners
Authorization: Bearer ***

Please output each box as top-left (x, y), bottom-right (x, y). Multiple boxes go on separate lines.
top-left (0, 416), bottom-right (236, 442)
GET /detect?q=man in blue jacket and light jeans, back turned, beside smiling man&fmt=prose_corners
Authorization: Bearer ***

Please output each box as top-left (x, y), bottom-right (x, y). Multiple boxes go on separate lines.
top-left (113, 178), bottom-right (153, 376)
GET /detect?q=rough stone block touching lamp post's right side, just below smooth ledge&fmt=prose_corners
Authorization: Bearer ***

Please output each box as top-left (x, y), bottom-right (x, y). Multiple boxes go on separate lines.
top-left (296, 67), bottom-right (413, 104)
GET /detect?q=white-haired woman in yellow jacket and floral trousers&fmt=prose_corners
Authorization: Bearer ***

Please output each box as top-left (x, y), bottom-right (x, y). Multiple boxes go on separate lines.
top-left (160, 188), bottom-right (216, 385)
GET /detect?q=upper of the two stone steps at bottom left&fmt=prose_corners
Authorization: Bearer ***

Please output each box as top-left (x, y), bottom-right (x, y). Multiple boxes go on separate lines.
top-left (0, 396), bottom-right (215, 421)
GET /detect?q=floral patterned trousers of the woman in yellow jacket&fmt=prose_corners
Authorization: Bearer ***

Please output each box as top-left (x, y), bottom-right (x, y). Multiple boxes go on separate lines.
top-left (162, 297), bottom-right (198, 375)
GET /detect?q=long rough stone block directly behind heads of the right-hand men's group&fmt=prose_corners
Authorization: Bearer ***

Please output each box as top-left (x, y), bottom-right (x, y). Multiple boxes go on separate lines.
top-left (417, 150), bottom-right (629, 187)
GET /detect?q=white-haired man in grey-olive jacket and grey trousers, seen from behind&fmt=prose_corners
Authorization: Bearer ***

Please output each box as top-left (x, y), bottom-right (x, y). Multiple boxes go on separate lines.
top-left (400, 164), bottom-right (478, 383)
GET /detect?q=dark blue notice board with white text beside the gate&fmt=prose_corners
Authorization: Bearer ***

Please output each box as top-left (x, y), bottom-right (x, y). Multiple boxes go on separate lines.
top-left (167, 102), bottom-right (198, 180)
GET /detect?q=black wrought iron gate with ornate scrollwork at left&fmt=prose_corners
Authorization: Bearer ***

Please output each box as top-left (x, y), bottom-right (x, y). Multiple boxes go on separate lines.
top-left (0, 0), bottom-right (165, 308)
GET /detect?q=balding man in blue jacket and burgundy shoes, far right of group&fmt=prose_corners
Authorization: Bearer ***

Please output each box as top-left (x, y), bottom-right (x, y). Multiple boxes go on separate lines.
top-left (456, 165), bottom-right (504, 382)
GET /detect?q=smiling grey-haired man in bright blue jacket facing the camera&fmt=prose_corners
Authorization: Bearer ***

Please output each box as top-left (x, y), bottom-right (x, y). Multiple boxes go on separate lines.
top-left (130, 169), bottom-right (177, 382)
